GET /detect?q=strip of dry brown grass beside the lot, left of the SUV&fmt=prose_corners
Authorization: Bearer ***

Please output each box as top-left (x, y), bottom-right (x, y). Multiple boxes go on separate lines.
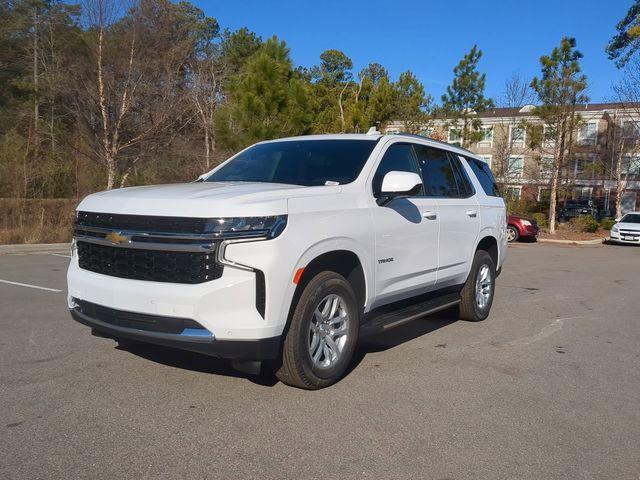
top-left (0, 198), bottom-right (76, 244)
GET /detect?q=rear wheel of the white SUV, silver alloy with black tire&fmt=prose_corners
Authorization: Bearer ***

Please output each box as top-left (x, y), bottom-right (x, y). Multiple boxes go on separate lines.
top-left (460, 250), bottom-right (496, 322)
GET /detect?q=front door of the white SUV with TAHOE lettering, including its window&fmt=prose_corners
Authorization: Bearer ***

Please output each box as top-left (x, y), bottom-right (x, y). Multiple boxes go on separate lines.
top-left (371, 143), bottom-right (439, 306)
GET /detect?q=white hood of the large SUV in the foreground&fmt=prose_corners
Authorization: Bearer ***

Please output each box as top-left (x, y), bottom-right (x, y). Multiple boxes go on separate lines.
top-left (78, 182), bottom-right (342, 217)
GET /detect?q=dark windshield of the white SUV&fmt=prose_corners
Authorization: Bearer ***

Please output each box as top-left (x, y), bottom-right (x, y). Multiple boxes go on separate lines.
top-left (205, 140), bottom-right (376, 187)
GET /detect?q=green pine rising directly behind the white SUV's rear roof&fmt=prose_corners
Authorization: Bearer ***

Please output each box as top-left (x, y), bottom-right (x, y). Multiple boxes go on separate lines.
top-left (442, 45), bottom-right (493, 146)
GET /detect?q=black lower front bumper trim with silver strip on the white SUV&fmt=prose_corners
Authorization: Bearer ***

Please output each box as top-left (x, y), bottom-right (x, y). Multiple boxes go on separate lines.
top-left (70, 306), bottom-right (280, 360)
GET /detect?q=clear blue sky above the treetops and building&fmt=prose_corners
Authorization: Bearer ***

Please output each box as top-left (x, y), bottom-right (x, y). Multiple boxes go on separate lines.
top-left (195, 0), bottom-right (632, 102)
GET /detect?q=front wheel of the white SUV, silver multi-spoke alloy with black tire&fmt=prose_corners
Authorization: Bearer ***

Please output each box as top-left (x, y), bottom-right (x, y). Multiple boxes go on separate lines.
top-left (275, 271), bottom-right (360, 390)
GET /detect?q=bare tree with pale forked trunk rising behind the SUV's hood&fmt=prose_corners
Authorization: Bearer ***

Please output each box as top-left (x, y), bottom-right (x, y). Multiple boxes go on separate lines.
top-left (78, 0), bottom-right (191, 189)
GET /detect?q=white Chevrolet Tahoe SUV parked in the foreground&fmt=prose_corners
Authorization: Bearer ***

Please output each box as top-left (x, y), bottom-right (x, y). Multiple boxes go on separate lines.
top-left (68, 132), bottom-right (507, 389)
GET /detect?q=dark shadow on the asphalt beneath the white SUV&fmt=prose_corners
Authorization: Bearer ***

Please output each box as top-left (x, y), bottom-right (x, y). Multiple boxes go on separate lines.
top-left (116, 308), bottom-right (458, 387)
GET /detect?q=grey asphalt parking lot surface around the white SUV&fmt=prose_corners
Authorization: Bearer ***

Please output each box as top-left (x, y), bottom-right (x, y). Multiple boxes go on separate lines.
top-left (0, 244), bottom-right (640, 479)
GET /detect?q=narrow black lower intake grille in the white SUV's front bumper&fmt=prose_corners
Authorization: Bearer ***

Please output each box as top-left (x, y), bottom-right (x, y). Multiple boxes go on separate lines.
top-left (73, 298), bottom-right (207, 334)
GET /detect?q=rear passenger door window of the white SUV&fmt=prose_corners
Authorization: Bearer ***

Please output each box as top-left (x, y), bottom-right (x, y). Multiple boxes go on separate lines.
top-left (416, 145), bottom-right (460, 197)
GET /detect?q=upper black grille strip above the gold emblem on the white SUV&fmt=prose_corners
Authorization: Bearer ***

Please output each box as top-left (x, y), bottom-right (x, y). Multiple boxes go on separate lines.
top-left (76, 211), bottom-right (207, 234)
